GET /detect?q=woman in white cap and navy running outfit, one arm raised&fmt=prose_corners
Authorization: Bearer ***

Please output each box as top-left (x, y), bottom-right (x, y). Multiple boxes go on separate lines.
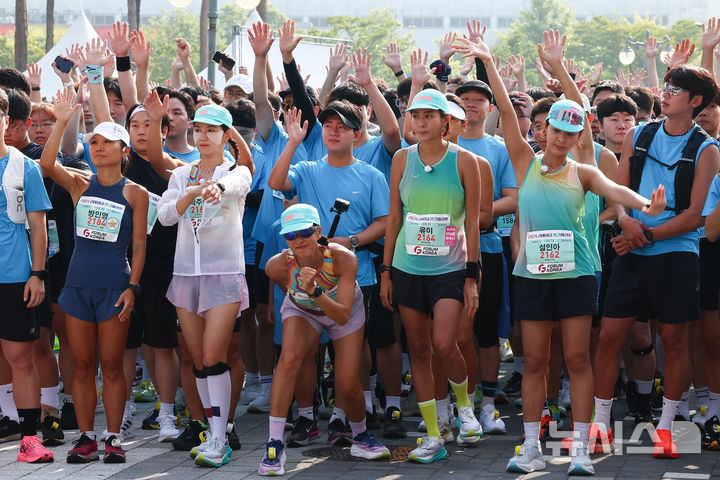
top-left (40, 88), bottom-right (148, 463)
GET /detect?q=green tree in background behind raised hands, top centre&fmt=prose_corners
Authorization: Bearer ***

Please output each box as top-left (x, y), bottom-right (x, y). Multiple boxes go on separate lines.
top-left (303, 7), bottom-right (415, 85)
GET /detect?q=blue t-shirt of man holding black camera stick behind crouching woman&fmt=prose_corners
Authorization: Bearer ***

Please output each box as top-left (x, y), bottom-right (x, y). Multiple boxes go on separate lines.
top-left (284, 157), bottom-right (390, 287)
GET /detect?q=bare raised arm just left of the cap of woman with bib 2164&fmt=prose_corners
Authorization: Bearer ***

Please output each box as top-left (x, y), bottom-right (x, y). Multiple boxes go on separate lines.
top-left (348, 49), bottom-right (400, 155)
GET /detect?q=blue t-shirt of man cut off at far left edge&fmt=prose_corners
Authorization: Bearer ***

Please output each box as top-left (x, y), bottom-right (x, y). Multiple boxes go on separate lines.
top-left (0, 153), bottom-right (52, 283)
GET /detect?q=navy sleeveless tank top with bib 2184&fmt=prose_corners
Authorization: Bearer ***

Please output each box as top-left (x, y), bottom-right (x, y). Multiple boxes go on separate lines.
top-left (65, 175), bottom-right (133, 290)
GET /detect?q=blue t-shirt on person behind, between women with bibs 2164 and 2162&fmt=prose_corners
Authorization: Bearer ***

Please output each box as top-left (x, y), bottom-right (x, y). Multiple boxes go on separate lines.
top-left (458, 135), bottom-right (518, 253)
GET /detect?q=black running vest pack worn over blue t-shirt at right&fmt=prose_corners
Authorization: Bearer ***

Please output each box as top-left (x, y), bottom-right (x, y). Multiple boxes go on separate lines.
top-left (630, 122), bottom-right (711, 215)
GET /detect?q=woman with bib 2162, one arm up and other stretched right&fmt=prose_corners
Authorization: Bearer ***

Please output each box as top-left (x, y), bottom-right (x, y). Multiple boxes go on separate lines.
top-left (456, 31), bottom-right (665, 475)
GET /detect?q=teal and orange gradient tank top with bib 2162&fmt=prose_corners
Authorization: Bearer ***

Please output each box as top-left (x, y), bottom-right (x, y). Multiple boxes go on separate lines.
top-left (513, 157), bottom-right (595, 280)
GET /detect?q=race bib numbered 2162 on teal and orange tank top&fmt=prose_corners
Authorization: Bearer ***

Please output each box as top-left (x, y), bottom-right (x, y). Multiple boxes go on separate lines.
top-left (525, 230), bottom-right (575, 275)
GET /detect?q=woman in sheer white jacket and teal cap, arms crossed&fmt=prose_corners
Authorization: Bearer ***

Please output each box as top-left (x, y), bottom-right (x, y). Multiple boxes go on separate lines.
top-left (157, 103), bottom-right (252, 467)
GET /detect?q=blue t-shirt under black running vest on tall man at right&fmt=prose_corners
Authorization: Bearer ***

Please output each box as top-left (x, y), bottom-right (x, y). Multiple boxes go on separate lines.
top-left (630, 121), bottom-right (719, 256)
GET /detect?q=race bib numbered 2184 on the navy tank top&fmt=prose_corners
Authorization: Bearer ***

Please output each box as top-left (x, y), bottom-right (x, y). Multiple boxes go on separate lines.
top-left (75, 197), bottom-right (125, 242)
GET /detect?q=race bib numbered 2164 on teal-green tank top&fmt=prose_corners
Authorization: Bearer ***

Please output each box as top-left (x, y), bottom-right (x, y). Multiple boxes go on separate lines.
top-left (405, 213), bottom-right (457, 257)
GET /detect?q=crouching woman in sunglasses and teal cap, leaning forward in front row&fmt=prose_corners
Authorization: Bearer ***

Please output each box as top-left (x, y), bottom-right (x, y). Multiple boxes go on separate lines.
top-left (258, 203), bottom-right (390, 475)
